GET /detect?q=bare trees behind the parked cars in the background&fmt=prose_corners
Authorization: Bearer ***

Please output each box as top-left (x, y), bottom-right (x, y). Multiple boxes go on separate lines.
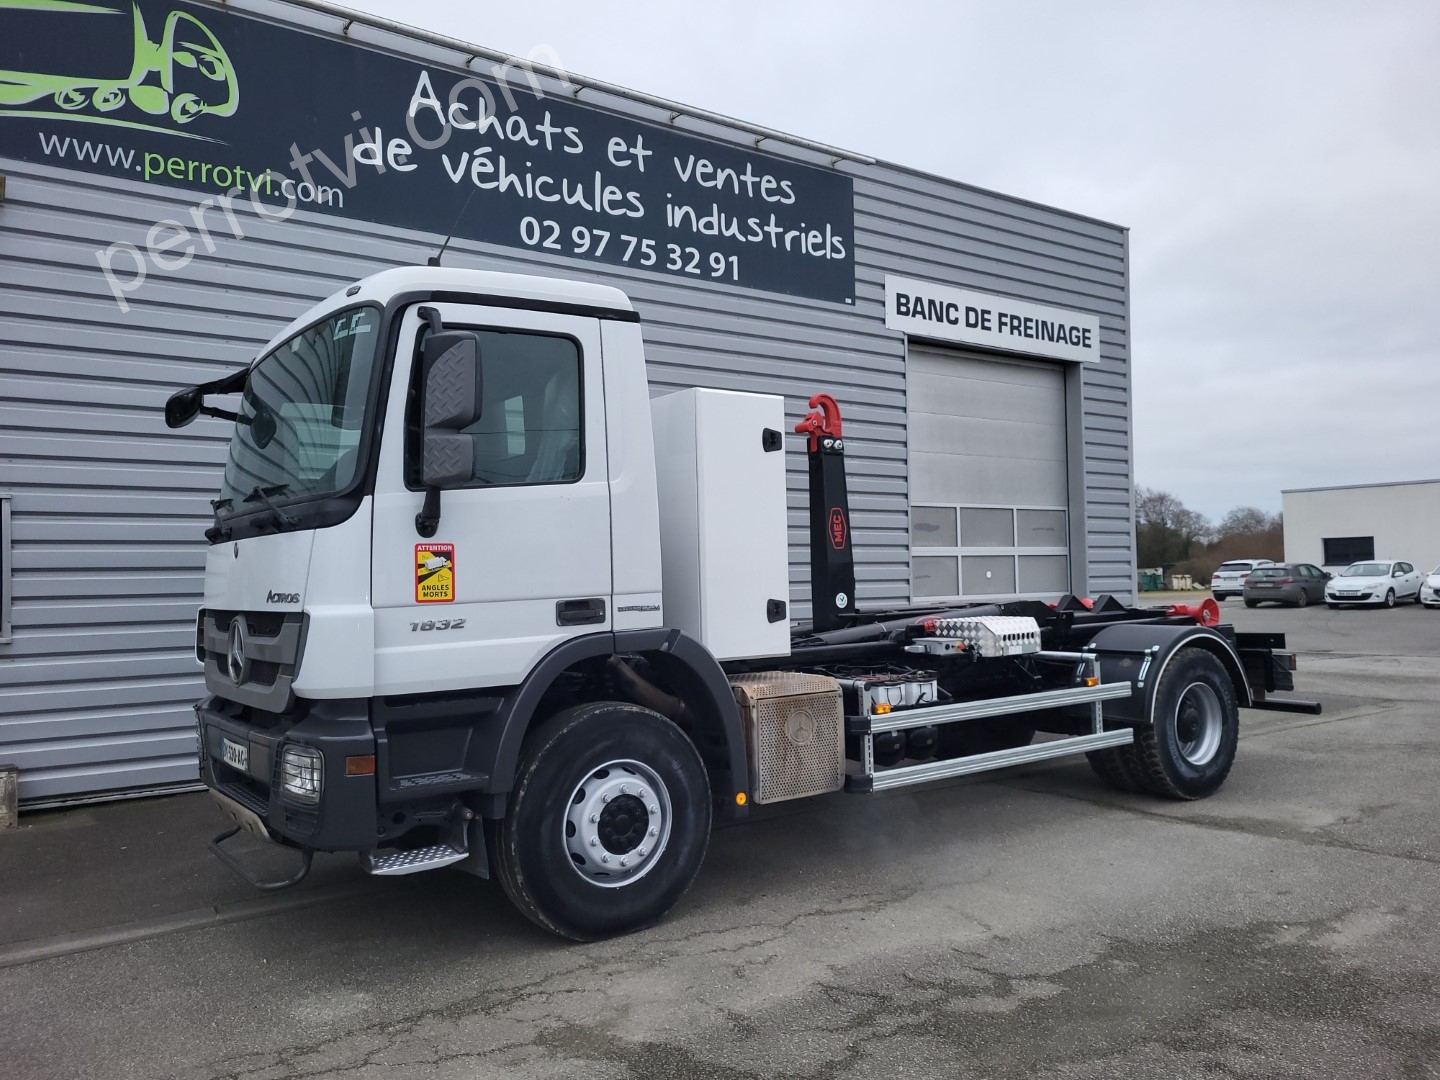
top-left (1135, 487), bottom-right (1284, 582)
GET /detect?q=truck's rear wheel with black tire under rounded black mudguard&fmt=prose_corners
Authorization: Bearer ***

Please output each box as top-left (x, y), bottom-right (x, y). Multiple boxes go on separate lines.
top-left (1132, 648), bottom-right (1240, 799)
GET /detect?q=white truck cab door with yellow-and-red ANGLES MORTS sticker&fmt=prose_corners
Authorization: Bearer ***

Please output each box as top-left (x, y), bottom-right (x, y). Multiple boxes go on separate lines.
top-left (372, 304), bottom-right (612, 694)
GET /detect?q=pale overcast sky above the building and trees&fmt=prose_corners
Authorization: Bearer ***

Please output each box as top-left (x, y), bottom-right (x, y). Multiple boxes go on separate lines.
top-left (351, 0), bottom-right (1440, 518)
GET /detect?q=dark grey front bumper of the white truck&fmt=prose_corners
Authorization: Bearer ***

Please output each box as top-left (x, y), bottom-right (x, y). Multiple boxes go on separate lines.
top-left (196, 697), bottom-right (376, 851)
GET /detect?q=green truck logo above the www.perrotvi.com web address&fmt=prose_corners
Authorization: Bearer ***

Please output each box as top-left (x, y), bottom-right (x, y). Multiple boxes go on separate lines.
top-left (0, 0), bottom-right (240, 138)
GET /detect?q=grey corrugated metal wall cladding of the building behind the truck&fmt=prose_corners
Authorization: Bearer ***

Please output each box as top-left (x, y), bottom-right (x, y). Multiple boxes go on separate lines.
top-left (0, 2), bottom-right (1133, 801)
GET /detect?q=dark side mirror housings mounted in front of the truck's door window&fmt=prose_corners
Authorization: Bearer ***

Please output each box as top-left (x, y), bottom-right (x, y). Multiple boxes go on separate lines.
top-left (419, 330), bottom-right (485, 488)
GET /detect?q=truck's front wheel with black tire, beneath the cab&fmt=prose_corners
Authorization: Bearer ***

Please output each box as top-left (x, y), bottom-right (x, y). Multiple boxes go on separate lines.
top-left (491, 701), bottom-right (711, 942)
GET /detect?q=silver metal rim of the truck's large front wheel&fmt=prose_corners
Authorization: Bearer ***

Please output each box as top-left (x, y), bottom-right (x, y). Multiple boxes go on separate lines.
top-left (563, 760), bottom-right (672, 888)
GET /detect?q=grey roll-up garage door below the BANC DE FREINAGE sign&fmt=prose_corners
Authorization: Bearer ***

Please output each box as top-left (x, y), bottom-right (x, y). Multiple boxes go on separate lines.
top-left (906, 343), bottom-right (1070, 600)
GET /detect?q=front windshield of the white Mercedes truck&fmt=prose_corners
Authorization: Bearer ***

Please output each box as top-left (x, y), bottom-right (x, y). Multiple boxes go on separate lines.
top-left (220, 307), bottom-right (380, 514)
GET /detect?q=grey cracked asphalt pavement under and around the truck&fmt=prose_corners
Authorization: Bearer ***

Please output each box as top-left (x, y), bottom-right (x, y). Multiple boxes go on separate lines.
top-left (0, 600), bottom-right (1440, 1080)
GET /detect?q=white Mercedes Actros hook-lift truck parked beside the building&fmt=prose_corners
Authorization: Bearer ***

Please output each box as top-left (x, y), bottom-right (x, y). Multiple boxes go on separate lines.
top-left (166, 266), bottom-right (1319, 940)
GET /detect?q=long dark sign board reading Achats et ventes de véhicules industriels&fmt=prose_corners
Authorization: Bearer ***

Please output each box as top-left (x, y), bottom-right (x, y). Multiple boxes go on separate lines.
top-left (0, 0), bottom-right (855, 302)
